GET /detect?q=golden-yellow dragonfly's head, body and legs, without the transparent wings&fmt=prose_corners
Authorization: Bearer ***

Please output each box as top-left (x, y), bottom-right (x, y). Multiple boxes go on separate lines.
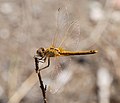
top-left (35, 47), bottom-right (97, 71)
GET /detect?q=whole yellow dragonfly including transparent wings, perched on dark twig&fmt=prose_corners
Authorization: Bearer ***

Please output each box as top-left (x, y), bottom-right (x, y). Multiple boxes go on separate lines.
top-left (34, 4), bottom-right (97, 93)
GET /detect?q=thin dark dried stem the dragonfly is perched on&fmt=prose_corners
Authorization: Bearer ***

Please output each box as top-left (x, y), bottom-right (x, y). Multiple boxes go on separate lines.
top-left (35, 58), bottom-right (47, 103)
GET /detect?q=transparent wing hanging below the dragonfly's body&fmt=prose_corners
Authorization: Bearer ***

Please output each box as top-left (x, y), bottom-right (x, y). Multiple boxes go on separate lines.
top-left (41, 57), bottom-right (72, 94)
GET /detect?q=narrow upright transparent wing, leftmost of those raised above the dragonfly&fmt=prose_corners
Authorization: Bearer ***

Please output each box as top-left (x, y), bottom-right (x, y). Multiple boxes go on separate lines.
top-left (52, 8), bottom-right (69, 47)
